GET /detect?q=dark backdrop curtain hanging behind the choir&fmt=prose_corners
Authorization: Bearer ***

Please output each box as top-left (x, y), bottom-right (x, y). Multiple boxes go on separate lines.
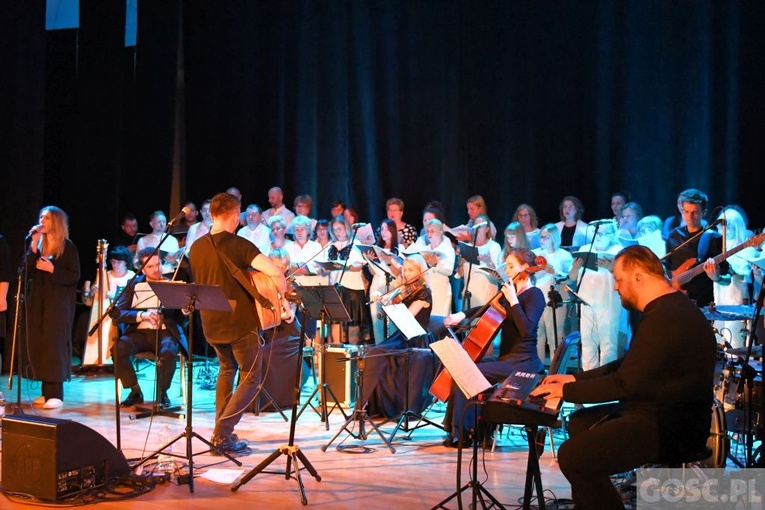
top-left (0, 0), bottom-right (765, 277)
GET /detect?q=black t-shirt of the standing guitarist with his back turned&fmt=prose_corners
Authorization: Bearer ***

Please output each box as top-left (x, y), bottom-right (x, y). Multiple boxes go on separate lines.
top-left (189, 232), bottom-right (260, 343)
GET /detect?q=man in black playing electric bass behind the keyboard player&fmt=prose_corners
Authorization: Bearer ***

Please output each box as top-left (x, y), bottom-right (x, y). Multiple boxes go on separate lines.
top-left (664, 188), bottom-right (728, 306)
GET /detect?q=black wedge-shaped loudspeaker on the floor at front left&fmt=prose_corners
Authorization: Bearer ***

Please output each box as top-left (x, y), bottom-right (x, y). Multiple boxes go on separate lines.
top-left (3, 416), bottom-right (130, 501)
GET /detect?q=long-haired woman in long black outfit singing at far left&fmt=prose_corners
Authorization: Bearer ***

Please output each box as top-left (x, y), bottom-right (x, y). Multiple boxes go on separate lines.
top-left (24, 205), bottom-right (80, 409)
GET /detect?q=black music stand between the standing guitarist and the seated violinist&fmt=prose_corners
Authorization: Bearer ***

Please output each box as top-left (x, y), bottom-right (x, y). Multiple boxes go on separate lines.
top-left (295, 285), bottom-right (351, 430)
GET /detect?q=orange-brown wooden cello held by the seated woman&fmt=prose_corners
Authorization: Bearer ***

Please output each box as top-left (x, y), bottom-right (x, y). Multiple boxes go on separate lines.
top-left (430, 256), bottom-right (547, 402)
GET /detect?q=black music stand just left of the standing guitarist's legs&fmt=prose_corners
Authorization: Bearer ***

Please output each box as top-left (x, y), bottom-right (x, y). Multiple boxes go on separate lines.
top-left (135, 281), bottom-right (242, 492)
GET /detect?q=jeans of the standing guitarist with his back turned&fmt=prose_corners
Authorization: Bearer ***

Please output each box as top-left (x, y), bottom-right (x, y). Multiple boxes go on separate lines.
top-left (211, 332), bottom-right (262, 438)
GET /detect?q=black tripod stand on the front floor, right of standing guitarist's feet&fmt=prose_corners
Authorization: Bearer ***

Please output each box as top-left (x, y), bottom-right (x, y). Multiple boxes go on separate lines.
top-left (231, 290), bottom-right (321, 506)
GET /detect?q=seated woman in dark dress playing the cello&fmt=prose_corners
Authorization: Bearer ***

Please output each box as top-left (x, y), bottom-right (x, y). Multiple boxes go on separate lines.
top-left (444, 249), bottom-right (545, 447)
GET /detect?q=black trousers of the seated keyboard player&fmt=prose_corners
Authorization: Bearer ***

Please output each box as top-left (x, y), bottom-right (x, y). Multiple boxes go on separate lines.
top-left (558, 404), bottom-right (660, 510)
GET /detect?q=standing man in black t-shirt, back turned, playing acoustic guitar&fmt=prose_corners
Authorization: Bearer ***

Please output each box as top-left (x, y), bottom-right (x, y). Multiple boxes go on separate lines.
top-left (189, 193), bottom-right (291, 453)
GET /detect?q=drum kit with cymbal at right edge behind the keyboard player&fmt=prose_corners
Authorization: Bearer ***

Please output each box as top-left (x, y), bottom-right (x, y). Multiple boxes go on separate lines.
top-left (701, 305), bottom-right (765, 467)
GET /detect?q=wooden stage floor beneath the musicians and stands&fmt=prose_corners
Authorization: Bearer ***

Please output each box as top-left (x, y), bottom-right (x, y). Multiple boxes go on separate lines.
top-left (0, 360), bottom-right (620, 510)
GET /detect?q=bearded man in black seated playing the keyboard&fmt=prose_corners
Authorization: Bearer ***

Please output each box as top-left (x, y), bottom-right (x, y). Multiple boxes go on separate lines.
top-left (532, 246), bottom-right (715, 510)
